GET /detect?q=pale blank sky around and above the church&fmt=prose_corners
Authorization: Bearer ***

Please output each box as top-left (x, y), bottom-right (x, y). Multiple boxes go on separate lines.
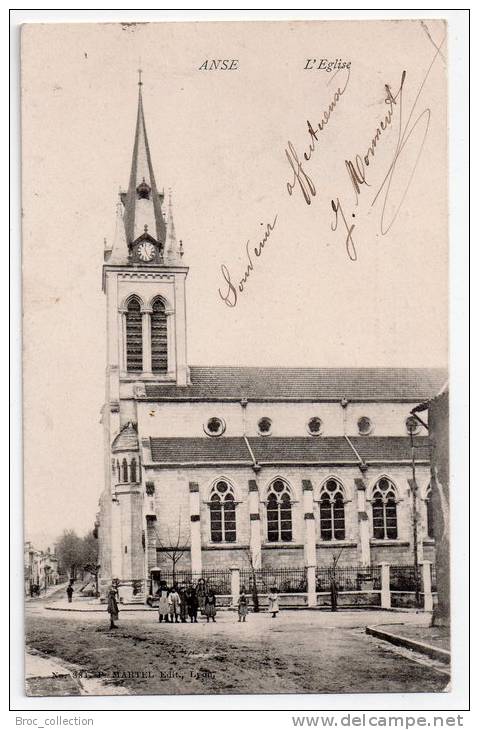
top-left (22, 21), bottom-right (448, 547)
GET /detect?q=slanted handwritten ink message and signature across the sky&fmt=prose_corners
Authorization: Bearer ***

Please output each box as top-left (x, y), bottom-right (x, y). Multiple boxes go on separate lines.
top-left (218, 29), bottom-right (445, 307)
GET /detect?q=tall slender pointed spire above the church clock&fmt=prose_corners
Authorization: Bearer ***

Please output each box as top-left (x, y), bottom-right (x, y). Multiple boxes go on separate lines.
top-left (124, 75), bottom-right (166, 246)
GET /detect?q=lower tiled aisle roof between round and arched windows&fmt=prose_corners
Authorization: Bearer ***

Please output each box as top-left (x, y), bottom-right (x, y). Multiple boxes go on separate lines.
top-left (146, 436), bottom-right (429, 466)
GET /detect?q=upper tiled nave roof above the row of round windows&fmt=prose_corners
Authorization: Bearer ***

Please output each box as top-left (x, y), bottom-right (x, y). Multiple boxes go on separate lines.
top-left (146, 367), bottom-right (447, 402)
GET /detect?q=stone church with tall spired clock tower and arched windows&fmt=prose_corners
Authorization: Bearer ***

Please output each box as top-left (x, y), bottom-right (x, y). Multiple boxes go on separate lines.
top-left (98, 81), bottom-right (446, 601)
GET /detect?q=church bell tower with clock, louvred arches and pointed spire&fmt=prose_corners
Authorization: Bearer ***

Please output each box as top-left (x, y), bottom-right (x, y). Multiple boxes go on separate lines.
top-left (100, 71), bottom-right (189, 595)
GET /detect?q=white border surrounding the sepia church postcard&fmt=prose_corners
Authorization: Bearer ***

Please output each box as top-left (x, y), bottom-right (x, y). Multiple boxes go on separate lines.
top-left (7, 8), bottom-right (469, 716)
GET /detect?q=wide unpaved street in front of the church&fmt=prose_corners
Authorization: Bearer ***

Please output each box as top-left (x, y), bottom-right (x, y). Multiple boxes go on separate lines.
top-left (26, 599), bottom-right (449, 694)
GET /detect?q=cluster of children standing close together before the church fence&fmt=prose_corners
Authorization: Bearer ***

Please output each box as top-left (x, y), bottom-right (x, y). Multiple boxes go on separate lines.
top-left (156, 579), bottom-right (216, 623)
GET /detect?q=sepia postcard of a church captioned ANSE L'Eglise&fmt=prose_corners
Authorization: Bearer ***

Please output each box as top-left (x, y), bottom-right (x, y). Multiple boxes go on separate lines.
top-left (21, 19), bottom-right (451, 697)
